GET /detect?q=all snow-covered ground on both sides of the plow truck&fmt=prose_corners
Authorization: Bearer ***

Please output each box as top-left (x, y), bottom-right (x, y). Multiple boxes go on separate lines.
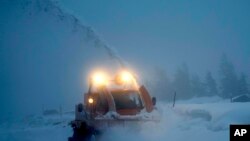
top-left (0, 97), bottom-right (250, 141)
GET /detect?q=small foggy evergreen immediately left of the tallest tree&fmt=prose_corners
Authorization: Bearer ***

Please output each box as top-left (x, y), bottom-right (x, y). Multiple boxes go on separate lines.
top-left (205, 72), bottom-right (218, 96)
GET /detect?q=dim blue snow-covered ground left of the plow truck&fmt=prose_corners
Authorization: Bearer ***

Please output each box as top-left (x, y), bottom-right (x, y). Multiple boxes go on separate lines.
top-left (0, 114), bottom-right (74, 141)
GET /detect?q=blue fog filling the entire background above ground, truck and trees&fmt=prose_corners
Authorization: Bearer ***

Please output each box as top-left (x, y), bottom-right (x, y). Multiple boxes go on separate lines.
top-left (0, 0), bottom-right (250, 123)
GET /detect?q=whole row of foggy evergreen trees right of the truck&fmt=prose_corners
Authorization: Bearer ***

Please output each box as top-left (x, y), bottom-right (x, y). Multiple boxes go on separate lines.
top-left (148, 55), bottom-right (249, 101)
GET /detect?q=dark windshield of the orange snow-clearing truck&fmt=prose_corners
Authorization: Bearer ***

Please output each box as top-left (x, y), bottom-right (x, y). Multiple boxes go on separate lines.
top-left (111, 91), bottom-right (142, 110)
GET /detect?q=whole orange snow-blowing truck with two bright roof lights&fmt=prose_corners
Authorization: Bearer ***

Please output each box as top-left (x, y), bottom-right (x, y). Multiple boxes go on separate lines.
top-left (68, 71), bottom-right (159, 141)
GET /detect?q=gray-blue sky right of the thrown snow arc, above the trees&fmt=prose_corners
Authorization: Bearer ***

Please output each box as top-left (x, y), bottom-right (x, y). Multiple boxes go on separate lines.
top-left (61, 0), bottom-right (250, 77)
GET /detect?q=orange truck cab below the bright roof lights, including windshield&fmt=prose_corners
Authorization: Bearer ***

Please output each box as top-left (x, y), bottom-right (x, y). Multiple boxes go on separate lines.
top-left (84, 86), bottom-right (154, 118)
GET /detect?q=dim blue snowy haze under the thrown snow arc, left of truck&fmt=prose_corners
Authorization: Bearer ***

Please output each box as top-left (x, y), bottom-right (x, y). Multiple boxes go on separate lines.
top-left (0, 0), bottom-right (127, 120)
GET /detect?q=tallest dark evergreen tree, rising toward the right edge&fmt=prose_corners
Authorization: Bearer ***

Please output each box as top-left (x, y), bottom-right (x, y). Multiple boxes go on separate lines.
top-left (219, 54), bottom-right (239, 98)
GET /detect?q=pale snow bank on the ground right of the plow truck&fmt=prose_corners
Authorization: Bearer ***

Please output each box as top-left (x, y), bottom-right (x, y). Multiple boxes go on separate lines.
top-left (100, 98), bottom-right (250, 141)
